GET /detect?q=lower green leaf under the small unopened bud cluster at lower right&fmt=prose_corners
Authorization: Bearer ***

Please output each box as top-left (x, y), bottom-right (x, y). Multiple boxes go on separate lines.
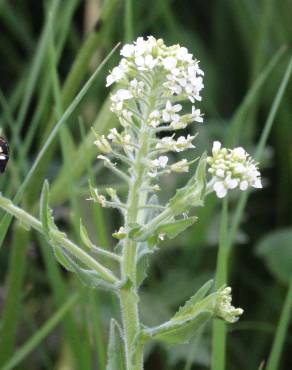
top-left (147, 311), bottom-right (212, 344)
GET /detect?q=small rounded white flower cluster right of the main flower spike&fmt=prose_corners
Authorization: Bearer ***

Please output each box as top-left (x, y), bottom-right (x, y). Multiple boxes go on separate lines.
top-left (207, 141), bottom-right (262, 198)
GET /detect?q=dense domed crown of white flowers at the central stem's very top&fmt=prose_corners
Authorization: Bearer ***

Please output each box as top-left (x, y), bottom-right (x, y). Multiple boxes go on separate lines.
top-left (107, 36), bottom-right (204, 108)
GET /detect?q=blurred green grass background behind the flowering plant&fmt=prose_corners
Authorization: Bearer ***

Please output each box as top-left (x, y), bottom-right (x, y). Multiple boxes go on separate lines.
top-left (0, 0), bottom-right (292, 370)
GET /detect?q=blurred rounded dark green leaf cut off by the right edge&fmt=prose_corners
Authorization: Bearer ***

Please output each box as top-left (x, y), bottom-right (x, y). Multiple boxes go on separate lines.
top-left (256, 228), bottom-right (292, 284)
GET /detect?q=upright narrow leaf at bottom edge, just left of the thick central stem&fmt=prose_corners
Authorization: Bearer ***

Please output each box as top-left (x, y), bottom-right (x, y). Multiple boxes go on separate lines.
top-left (106, 319), bottom-right (126, 370)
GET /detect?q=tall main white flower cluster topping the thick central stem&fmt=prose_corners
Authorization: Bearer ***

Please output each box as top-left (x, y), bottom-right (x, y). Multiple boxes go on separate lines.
top-left (95, 36), bottom-right (203, 189)
